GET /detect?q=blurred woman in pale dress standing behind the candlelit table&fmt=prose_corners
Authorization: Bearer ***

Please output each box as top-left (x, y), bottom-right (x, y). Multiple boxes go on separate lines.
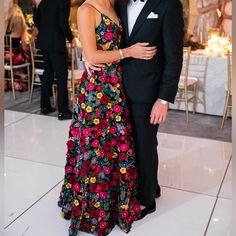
top-left (193, 0), bottom-right (219, 44)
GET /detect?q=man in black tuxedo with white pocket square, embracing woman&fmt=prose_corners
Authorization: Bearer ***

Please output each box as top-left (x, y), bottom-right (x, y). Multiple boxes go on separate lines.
top-left (87, 0), bottom-right (184, 218)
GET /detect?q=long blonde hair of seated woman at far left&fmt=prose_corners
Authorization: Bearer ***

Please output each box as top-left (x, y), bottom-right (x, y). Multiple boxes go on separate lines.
top-left (7, 4), bottom-right (27, 35)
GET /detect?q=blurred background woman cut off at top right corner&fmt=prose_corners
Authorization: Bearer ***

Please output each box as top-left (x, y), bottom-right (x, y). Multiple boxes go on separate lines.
top-left (218, 0), bottom-right (232, 39)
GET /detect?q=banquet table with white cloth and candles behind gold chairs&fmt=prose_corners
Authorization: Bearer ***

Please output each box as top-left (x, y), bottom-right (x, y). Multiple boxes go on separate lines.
top-left (170, 50), bottom-right (228, 116)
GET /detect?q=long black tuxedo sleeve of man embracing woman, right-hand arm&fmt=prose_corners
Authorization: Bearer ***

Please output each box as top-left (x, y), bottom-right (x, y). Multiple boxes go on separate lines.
top-left (158, 0), bottom-right (184, 103)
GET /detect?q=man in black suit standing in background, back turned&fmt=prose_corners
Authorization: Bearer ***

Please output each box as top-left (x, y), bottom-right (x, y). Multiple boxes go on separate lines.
top-left (34, 0), bottom-right (75, 120)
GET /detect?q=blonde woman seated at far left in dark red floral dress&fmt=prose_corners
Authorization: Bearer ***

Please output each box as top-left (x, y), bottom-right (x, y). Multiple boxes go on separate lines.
top-left (5, 4), bottom-right (30, 92)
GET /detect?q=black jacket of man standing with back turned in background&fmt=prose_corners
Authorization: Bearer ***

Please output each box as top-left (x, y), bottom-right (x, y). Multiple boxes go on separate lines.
top-left (34, 0), bottom-right (73, 52)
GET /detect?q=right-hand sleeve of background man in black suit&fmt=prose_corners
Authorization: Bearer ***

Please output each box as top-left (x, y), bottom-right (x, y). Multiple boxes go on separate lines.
top-left (59, 0), bottom-right (73, 42)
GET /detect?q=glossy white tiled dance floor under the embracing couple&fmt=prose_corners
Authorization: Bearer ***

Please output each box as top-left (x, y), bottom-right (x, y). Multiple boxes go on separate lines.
top-left (5, 111), bottom-right (232, 236)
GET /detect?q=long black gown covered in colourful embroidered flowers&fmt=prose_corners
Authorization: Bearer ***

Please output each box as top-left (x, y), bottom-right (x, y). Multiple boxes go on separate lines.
top-left (58, 14), bottom-right (140, 236)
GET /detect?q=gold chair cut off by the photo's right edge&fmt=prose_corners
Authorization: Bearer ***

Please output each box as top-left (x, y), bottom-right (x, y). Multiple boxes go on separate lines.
top-left (221, 51), bottom-right (232, 129)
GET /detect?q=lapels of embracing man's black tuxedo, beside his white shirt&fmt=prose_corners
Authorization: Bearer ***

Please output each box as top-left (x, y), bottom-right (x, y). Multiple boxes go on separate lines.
top-left (126, 0), bottom-right (161, 40)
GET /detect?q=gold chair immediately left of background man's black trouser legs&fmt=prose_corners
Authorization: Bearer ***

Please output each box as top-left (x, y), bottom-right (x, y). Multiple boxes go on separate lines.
top-left (29, 42), bottom-right (56, 105)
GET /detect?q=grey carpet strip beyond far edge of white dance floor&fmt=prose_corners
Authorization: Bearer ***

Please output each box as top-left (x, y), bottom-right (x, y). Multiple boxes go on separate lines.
top-left (5, 88), bottom-right (232, 142)
